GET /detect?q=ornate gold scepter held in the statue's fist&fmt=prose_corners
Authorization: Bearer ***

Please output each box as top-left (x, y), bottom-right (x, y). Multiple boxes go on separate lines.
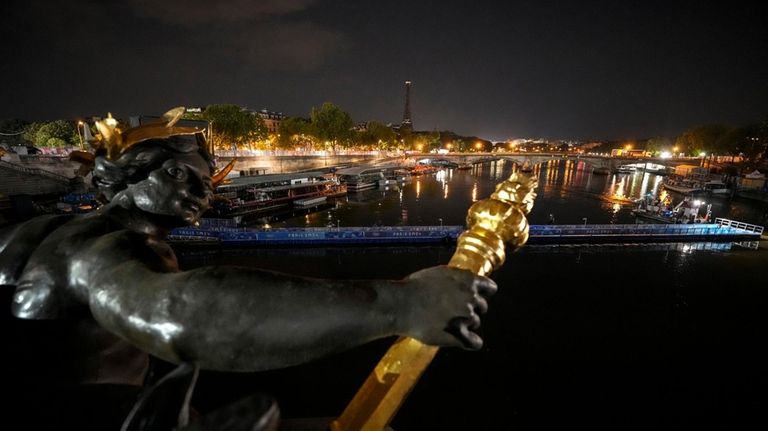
top-left (331, 172), bottom-right (537, 431)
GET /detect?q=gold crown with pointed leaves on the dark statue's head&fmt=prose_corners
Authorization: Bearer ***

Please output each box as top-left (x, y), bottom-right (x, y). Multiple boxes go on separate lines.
top-left (70, 106), bottom-right (235, 187)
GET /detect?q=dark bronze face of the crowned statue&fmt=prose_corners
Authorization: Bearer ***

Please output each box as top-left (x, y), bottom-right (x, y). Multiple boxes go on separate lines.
top-left (132, 153), bottom-right (213, 224)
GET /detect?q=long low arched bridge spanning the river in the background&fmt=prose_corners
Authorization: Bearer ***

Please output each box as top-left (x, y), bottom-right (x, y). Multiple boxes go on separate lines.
top-left (408, 152), bottom-right (701, 171)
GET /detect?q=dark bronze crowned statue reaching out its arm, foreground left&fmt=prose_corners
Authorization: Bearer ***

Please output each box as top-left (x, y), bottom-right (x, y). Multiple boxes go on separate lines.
top-left (0, 110), bottom-right (496, 430)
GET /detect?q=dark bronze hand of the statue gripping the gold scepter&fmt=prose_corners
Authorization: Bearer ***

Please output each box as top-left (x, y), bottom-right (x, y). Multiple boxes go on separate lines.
top-left (402, 266), bottom-right (496, 350)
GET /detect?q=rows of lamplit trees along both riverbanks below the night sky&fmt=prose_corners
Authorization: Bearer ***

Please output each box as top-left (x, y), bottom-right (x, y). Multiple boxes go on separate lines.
top-left (0, 102), bottom-right (768, 165)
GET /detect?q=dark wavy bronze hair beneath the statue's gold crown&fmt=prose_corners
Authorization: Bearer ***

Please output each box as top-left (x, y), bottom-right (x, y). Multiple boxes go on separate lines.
top-left (93, 133), bottom-right (214, 202)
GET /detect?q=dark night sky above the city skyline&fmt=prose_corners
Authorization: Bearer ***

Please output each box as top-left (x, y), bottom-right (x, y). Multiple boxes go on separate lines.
top-left (0, 0), bottom-right (768, 140)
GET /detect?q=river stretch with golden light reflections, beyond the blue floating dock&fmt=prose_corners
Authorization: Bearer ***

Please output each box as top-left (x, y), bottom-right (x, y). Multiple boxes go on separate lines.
top-left (272, 158), bottom-right (765, 230)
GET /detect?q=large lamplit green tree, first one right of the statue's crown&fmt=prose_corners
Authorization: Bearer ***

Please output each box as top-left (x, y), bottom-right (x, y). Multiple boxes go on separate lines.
top-left (201, 104), bottom-right (267, 151)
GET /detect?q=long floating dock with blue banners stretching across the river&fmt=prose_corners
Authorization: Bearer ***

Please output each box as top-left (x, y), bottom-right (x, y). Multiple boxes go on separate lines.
top-left (168, 219), bottom-right (763, 247)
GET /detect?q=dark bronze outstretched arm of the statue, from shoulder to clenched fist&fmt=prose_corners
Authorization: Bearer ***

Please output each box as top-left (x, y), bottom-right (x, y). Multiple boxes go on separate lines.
top-left (85, 231), bottom-right (495, 371)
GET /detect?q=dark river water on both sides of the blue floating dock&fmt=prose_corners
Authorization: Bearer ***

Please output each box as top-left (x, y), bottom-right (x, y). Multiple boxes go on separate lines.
top-left (180, 159), bottom-right (768, 431)
